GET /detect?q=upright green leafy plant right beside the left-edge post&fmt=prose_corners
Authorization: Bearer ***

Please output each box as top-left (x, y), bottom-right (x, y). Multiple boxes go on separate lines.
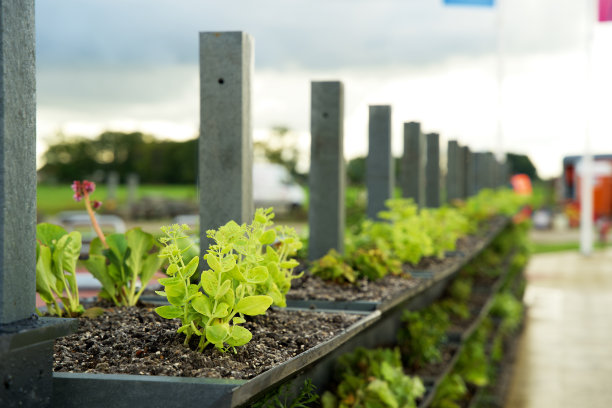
top-left (36, 223), bottom-right (83, 317)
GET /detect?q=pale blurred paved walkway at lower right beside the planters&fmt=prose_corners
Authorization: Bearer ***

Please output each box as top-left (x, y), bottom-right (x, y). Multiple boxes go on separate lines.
top-left (506, 249), bottom-right (612, 408)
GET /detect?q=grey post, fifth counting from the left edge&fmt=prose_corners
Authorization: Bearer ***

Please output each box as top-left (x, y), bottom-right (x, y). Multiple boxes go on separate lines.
top-left (401, 122), bottom-right (426, 207)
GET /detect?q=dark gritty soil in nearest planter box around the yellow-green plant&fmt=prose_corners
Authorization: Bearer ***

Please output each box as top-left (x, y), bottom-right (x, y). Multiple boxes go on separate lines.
top-left (53, 307), bottom-right (361, 379)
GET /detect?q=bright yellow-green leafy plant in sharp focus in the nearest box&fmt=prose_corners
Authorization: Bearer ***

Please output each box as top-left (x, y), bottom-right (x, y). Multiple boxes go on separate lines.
top-left (155, 209), bottom-right (301, 351)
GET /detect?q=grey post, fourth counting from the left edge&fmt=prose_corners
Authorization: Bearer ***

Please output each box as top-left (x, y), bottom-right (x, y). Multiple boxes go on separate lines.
top-left (366, 105), bottom-right (395, 219)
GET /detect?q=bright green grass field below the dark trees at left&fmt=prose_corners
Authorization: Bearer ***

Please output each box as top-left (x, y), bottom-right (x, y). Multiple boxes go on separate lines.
top-left (36, 184), bottom-right (197, 216)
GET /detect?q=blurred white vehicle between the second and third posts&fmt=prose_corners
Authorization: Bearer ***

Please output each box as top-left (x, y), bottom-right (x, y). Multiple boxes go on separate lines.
top-left (253, 163), bottom-right (306, 212)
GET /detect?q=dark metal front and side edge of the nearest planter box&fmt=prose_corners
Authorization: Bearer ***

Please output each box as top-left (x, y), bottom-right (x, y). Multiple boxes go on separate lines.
top-left (52, 311), bottom-right (380, 408)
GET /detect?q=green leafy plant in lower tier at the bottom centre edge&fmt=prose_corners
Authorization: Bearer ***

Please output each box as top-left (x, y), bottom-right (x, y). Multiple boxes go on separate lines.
top-left (321, 348), bottom-right (425, 408)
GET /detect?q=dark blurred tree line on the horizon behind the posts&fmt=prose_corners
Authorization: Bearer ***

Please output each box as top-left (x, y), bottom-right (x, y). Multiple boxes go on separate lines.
top-left (38, 127), bottom-right (538, 185)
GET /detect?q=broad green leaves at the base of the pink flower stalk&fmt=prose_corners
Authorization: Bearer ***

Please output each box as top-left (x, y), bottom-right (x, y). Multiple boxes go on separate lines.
top-left (85, 228), bottom-right (164, 306)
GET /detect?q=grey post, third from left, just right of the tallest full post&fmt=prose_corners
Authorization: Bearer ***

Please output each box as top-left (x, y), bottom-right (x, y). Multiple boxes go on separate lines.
top-left (308, 81), bottom-right (346, 260)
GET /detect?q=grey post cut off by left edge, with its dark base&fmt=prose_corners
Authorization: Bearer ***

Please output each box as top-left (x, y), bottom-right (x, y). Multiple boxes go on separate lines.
top-left (0, 0), bottom-right (76, 407)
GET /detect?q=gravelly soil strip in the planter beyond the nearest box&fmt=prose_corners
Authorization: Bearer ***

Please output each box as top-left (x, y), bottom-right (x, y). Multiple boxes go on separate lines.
top-left (287, 217), bottom-right (507, 302)
